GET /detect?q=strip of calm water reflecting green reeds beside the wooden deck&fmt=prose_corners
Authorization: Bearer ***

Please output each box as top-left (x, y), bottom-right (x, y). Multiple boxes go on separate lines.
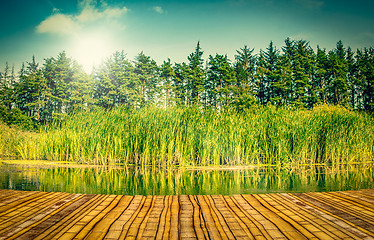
top-left (0, 164), bottom-right (374, 195)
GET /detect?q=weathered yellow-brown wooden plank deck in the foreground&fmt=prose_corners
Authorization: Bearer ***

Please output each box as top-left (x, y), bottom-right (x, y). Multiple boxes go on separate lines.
top-left (0, 189), bottom-right (374, 240)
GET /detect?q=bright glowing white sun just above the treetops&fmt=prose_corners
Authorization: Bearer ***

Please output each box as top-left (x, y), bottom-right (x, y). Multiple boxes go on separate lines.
top-left (71, 32), bottom-right (115, 73)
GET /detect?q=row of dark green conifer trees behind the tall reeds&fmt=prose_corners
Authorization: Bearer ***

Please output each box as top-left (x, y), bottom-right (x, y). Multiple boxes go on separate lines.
top-left (0, 38), bottom-right (374, 125)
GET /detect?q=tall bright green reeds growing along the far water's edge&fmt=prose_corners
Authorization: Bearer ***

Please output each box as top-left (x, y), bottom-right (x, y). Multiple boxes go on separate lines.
top-left (0, 105), bottom-right (374, 165)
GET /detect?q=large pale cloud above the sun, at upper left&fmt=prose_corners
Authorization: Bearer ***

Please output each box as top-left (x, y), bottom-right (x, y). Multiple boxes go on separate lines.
top-left (36, 0), bottom-right (129, 35)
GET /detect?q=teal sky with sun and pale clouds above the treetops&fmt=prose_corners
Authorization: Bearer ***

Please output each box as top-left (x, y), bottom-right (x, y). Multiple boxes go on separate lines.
top-left (0, 0), bottom-right (374, 72)
